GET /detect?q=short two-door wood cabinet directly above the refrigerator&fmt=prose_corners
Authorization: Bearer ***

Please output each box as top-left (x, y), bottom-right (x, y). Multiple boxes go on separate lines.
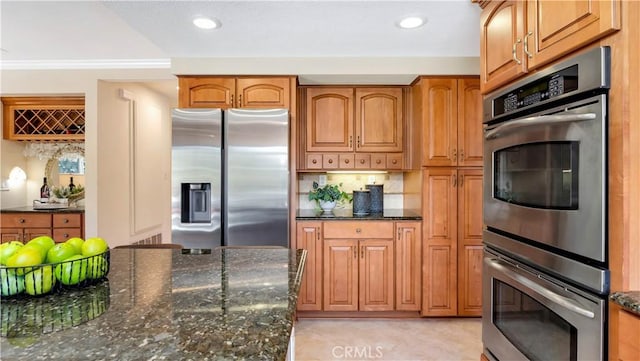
top-left (178, 76), bottom-right (292, 109)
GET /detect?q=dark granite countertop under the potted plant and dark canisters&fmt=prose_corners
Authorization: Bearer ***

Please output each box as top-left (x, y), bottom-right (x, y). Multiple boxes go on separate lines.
top-left (296, 209), bottom-right (422, 221)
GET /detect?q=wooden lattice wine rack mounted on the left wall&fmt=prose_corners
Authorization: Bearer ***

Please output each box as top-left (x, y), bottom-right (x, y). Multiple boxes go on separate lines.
top-left (2, 97), bottom-right (85, 141)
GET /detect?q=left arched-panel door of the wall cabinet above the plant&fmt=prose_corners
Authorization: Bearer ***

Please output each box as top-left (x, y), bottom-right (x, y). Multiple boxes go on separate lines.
top-left (306, 88), bottom-right (354, 152)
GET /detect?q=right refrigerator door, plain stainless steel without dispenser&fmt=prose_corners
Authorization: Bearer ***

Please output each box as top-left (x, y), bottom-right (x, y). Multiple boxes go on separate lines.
top-left (224, 109), bottom-right (289, 247)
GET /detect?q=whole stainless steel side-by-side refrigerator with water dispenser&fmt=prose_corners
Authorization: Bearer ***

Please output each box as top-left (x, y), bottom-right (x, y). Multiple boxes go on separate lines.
top-left (171, 109), bottom-right (289, 249)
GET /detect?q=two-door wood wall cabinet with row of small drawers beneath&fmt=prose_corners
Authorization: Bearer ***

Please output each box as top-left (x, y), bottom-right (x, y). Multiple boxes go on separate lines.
top-left (300, 87), bottom-right (404, 169)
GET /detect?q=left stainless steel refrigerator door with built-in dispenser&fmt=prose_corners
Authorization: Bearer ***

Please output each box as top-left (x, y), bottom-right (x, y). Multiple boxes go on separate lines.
top-left (171, 109), bottom-right (222, 249)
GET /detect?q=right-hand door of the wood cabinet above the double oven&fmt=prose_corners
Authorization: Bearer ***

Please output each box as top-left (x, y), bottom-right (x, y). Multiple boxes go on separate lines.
top-left (524, 0), bottom-right (621, 69)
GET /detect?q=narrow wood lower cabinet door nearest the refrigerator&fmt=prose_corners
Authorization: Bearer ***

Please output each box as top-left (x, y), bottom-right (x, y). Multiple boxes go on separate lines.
top-left (296, 222), bottom-right (322, 311)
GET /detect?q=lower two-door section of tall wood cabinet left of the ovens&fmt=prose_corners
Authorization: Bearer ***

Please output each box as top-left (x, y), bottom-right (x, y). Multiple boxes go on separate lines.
top-left (422, 167), bottom-right (483, 316)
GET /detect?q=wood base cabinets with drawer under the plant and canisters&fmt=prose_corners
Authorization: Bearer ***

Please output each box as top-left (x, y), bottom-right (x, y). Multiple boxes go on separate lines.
top-left (296, 221), bottom-right (422, 312)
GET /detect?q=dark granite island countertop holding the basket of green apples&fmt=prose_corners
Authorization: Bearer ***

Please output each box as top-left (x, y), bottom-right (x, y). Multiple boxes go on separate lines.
top-left (0, 249), bottom-right (306, 361)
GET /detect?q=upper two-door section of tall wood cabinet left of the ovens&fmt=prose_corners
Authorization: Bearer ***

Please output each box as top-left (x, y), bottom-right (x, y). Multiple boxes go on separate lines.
top-left (416, 77), bottom-right (483, 166)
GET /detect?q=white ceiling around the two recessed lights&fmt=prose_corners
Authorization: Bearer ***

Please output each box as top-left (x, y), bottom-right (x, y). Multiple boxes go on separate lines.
top-left (0, 0), bottom-right (480, 95)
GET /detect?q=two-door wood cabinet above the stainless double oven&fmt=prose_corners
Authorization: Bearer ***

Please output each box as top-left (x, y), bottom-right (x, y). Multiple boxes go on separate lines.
top-left (480, 0), bottom-right (621, 94)
